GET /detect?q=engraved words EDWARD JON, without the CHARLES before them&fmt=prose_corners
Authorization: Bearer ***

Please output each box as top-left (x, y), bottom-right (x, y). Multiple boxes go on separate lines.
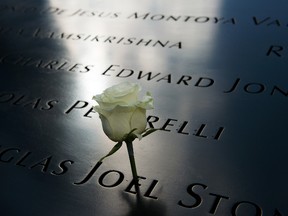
top-left (102, 64), bottom-right (288, 97)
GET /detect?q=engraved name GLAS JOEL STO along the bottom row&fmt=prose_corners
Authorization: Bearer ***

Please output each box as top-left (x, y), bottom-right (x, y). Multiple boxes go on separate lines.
top-left (0, 146), bottom-right (284, 216)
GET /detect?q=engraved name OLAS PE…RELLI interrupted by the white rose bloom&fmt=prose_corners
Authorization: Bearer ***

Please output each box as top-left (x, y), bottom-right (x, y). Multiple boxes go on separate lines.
top-left (0, 92), bottom-right (225, 141)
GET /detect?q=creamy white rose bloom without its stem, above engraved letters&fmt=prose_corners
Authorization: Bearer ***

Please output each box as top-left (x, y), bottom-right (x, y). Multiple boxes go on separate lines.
top-left (93, 82), bottom-right (153, 142)
